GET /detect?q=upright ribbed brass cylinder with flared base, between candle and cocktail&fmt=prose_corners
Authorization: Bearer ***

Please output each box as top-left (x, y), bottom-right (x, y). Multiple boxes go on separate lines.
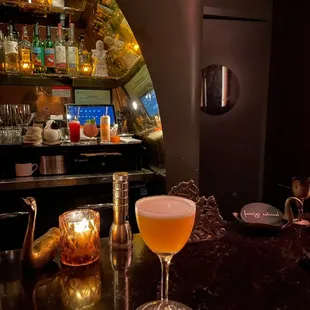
top-left (109, 172), bottom-right (132, 249)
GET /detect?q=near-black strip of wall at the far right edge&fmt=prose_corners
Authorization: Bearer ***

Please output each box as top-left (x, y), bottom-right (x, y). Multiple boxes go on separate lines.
top-left (264, 0), bottom-right (310, 211)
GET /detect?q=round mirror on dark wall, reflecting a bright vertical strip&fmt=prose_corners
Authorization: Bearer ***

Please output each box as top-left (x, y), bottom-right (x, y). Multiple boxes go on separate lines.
top-left (201, 65), bottom-right (239, 115)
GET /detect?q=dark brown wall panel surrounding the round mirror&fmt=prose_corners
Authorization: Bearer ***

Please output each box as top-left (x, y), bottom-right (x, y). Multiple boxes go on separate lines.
top-left (200, 1), bottom-right (271, 216)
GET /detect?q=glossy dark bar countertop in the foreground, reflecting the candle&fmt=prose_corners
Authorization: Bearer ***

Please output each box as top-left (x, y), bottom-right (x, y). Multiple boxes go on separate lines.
top-left (0, 223), bottom-right (310, 310)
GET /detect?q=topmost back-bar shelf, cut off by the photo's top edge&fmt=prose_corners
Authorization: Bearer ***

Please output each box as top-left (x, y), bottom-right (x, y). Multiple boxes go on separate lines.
top-left (0, 0), bottom-right (86, 14)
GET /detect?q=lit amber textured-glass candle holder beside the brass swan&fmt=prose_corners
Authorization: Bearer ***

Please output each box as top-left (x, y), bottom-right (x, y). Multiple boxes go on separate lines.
top-left (59, 209), bottom-right (100, 266)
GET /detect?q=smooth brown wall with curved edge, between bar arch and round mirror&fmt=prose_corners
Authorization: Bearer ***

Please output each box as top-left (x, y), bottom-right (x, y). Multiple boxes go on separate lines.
top-left (117, 0), bottom-right (202, 189)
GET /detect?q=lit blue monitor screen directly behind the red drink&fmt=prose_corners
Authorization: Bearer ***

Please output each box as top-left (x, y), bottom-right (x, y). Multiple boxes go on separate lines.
top-left (67, 104), bottom-right (115, 126)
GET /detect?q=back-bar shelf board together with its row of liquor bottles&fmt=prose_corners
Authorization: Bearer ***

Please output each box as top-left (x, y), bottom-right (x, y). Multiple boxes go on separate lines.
top-left (0, 23), bottom-right (139, 89)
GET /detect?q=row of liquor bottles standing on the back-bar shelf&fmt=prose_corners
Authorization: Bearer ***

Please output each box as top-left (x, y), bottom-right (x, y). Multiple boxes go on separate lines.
top-left (0, 23), bottom-right (97, 77)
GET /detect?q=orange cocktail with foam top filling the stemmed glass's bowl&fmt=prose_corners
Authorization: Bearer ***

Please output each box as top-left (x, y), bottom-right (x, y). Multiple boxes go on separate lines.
top-left (136, 196), bottom-right (196, 254)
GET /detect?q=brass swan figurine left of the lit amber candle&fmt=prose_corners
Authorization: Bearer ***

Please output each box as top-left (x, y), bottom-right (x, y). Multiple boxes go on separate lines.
top-left (20, 197), bottom-right (60, 269)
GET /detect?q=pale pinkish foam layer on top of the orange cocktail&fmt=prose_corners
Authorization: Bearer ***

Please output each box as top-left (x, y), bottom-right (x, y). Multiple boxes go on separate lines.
top-left (136, 195), bottom-right (196, 219)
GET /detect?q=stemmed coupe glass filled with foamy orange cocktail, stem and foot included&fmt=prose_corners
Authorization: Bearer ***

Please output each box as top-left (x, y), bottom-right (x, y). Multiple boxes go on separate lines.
top-left (136, 196), bottom-right (196, 310)
